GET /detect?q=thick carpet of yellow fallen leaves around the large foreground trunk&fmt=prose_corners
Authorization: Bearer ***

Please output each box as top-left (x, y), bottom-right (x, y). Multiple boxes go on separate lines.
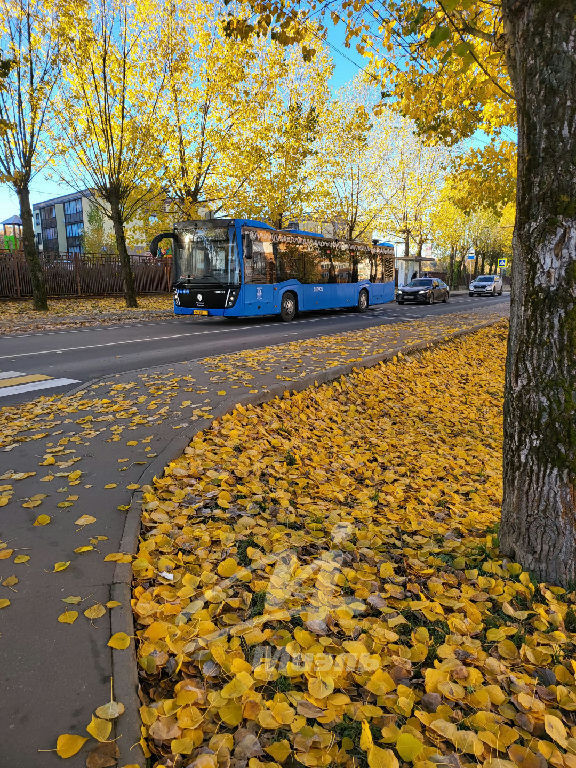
top-left (133, 324), bottom-right (576, 768)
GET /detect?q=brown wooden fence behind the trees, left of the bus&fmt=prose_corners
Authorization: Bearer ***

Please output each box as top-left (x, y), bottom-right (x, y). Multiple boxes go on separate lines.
top-left (0, 251), bottom-right (172, 299)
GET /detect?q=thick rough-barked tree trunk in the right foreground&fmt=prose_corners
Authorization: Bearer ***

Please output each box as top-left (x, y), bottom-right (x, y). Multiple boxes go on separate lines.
top-left (500, 0), bottom-right (576, 586)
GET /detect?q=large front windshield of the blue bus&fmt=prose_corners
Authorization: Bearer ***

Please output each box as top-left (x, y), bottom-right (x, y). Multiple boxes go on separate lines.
top-left (177, 225), bottom-right (240, 285)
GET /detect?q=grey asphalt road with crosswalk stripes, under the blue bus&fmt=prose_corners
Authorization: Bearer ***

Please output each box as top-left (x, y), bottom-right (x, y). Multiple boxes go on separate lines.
top-left (0, 294), bottom-right (509, 407)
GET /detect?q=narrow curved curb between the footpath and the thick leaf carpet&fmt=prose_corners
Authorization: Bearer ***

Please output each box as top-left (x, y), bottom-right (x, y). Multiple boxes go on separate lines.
top-left (108, 317), bottom-right (504, 768)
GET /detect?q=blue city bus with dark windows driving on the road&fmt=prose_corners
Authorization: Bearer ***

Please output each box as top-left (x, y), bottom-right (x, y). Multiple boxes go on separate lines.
top-left (150, 219), bottom-right (394, 321)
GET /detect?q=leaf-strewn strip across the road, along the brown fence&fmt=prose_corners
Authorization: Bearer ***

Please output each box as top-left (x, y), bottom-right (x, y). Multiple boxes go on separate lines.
top-left (0, 294), bottom-right (172, 335)
